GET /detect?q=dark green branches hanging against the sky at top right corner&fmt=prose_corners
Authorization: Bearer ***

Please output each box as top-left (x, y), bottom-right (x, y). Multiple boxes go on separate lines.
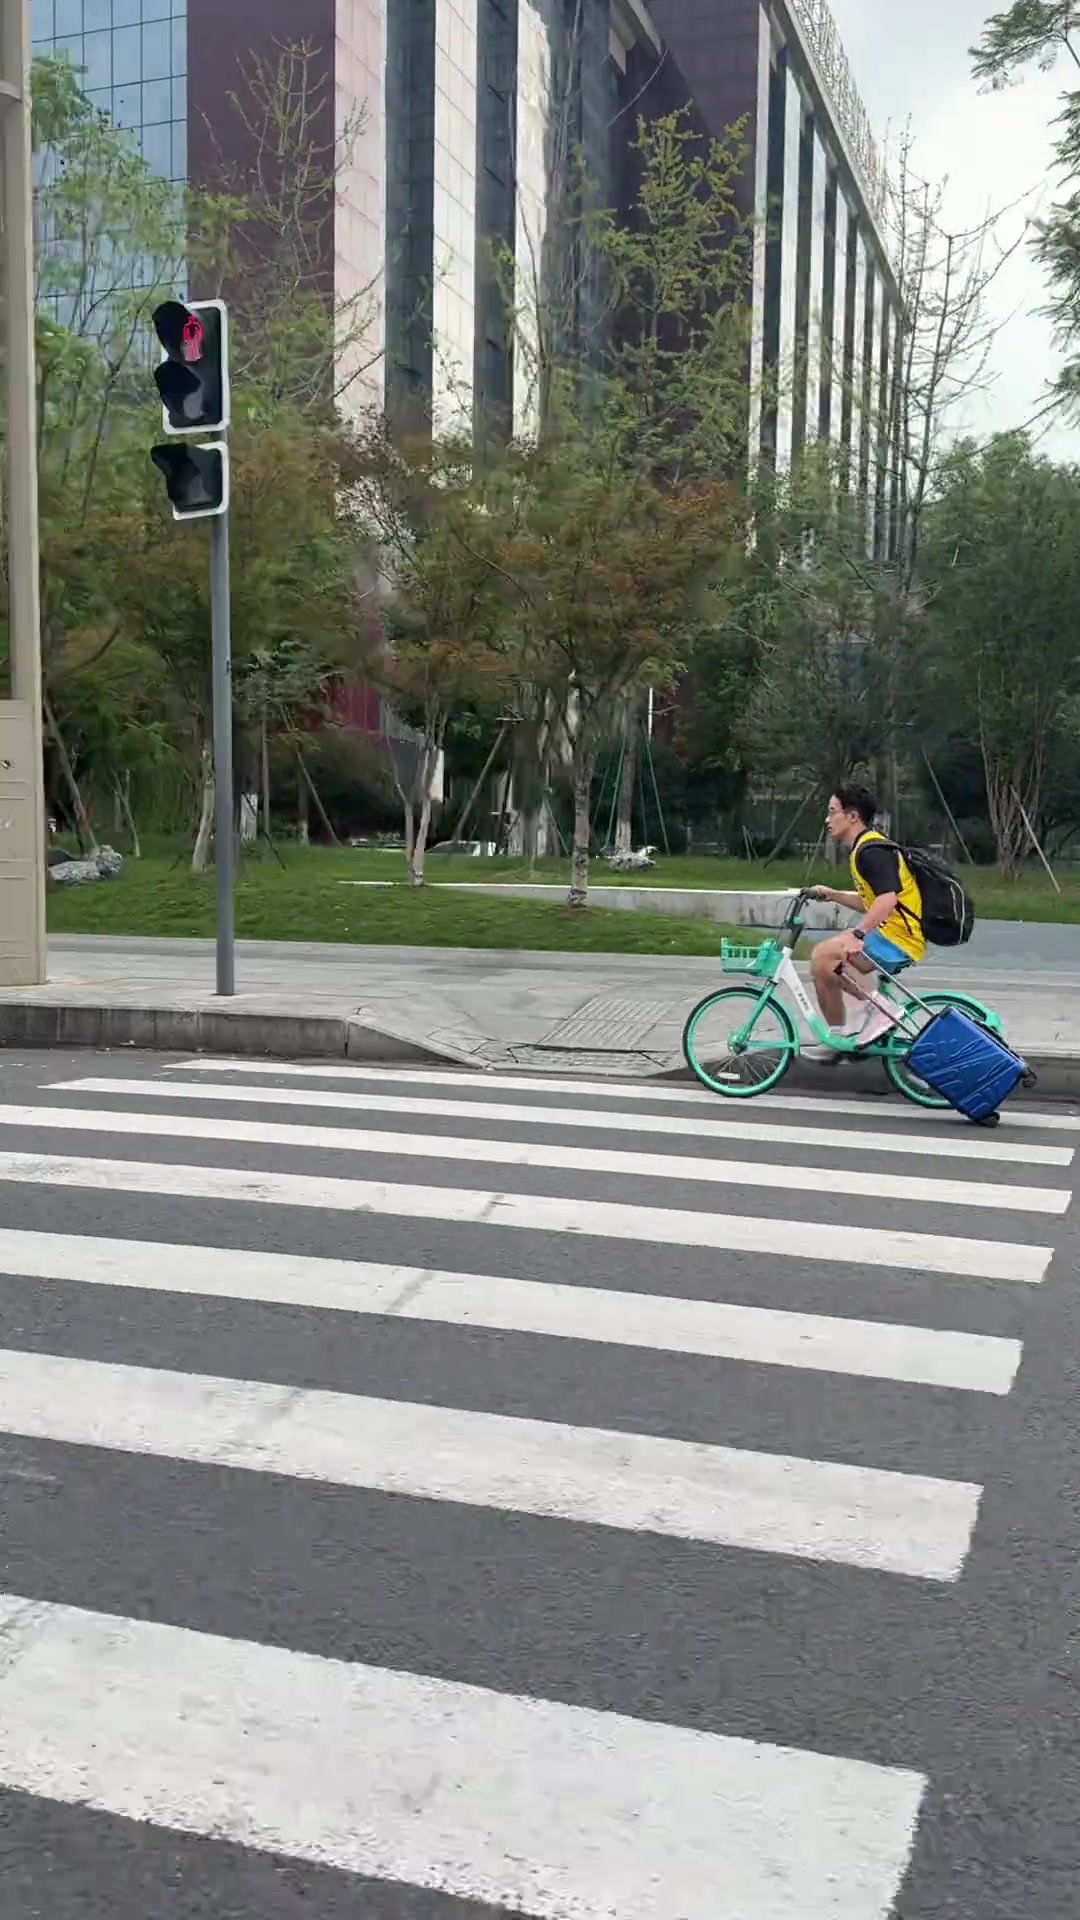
top-left (970, 0), bottom-right (1080, 415)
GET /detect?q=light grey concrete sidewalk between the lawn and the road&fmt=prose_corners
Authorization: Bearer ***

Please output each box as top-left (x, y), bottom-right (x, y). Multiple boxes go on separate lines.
top-left (0, 929), bottom-right (1080, 1098)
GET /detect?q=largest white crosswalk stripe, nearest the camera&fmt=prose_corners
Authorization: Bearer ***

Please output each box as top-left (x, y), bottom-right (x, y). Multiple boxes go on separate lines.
top-left (0, 1597), bottom-right (922, 1920)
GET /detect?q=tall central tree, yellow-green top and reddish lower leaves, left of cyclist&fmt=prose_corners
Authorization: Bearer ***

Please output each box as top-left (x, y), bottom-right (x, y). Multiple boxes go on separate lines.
top-left (492, 113), bottom-right (753, 906)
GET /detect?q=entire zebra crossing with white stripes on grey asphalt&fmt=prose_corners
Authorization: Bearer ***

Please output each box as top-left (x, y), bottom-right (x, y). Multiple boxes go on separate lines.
top-left (0, 1056), bottom-right (1080, 1920)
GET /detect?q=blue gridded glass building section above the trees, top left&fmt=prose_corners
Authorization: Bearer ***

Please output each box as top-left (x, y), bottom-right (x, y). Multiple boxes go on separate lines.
top-left (31, 0), bottom-right (188, 180)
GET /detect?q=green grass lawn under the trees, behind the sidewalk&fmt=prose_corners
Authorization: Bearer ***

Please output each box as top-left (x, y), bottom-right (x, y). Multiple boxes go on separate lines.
top-left (48, 845), bottom-right (1080, 954)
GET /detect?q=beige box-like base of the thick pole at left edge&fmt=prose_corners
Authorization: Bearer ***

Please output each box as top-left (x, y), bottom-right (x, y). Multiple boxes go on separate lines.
top-left (0, 701), bottom-right (46, 987)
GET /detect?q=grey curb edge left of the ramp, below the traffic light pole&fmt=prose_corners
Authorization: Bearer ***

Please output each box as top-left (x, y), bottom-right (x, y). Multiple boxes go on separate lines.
top-left (0, 1000), bottom-right (480, 1066)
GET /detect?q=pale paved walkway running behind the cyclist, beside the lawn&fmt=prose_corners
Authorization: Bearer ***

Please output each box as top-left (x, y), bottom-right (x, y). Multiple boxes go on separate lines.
top-left (0, 925), bottom-right (1080, 1073)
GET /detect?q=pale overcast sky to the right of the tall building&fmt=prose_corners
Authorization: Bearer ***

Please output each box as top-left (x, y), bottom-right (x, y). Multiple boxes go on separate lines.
top-left (830, 0), bottom-right (1080, 459)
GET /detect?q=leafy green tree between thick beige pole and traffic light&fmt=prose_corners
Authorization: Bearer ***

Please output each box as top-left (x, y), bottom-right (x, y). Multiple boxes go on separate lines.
top-left (4, 60), bottom-right (184, 847)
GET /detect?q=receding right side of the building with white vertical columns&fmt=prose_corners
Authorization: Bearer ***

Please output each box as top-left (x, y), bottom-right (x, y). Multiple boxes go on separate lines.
top-left (630, 0), bottom-right (901, 547)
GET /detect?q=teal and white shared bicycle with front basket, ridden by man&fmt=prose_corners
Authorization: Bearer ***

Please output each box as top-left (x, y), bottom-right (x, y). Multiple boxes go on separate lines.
top-left (682, 891), bottom-right (1001, 1108)
